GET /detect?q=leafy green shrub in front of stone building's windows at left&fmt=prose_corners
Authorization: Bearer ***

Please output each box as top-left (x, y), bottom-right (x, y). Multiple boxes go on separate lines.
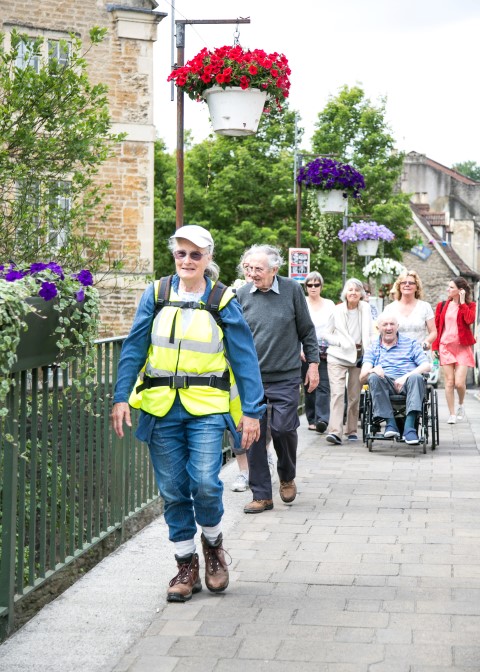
top-left (0, 28), bottom-right (122, 270)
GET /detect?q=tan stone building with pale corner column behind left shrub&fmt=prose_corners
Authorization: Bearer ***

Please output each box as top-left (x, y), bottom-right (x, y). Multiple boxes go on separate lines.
top-left (0, 0), bottom-right (166, 335)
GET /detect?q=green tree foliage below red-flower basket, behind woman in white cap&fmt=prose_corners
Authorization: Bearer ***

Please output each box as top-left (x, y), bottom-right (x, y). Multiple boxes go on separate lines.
top-left (155, 108), bottom-right (296, 282)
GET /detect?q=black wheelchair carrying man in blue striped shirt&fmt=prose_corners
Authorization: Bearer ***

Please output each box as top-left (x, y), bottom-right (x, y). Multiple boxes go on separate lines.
top-left (361, 382), bottom-right (439, 454)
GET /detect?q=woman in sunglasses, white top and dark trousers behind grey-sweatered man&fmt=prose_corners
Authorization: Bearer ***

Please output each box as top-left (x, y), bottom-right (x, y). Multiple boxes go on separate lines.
top-left (301, 271), bottom-right (335, 434)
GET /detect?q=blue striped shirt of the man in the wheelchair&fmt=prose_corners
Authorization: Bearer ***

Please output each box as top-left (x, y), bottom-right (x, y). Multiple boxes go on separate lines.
top-left (363, 334), bottom-right (428, 380)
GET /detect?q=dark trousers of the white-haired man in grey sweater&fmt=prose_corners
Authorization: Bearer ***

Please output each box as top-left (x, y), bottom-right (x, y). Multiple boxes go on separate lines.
top-left (247, 378), bottom-right (301, 499)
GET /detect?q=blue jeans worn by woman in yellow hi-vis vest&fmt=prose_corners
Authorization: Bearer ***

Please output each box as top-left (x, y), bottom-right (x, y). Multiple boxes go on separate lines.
top-left (137, 395), bottom-right (227, 541)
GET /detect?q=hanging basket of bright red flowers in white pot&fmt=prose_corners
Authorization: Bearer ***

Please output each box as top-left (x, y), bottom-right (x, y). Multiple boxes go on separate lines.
top-left (168, 45), bottom-right (291, 135)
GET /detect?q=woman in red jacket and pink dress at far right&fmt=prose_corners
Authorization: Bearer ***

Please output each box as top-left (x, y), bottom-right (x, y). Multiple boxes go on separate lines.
top-left (432, 277), bottom-right (476, 425)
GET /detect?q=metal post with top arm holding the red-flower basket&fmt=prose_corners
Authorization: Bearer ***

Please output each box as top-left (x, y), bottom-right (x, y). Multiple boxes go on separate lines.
top-left (175, 18), bottom-right (250, 229)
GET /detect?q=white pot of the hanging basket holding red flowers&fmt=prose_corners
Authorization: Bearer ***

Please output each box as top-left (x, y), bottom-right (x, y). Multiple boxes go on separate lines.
top-left (203, 86), bottom-right (267, 136)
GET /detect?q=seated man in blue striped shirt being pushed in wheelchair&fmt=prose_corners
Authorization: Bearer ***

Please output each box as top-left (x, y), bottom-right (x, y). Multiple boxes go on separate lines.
top-left (360, 313), bottom-right (431, 445)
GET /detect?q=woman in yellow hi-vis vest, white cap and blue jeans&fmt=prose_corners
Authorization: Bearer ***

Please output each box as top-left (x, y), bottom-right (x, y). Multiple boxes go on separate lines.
top-left (112, 225), bottom-right (265, 602)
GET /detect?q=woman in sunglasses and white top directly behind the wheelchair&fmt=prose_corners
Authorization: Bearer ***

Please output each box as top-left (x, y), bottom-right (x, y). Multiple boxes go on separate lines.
top-left (383, 270), bottom-right (437, 350)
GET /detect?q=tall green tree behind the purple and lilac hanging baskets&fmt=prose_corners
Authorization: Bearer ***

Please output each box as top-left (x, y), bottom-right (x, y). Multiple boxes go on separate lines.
top-left (303, 86), bottom-right (413, 298)
